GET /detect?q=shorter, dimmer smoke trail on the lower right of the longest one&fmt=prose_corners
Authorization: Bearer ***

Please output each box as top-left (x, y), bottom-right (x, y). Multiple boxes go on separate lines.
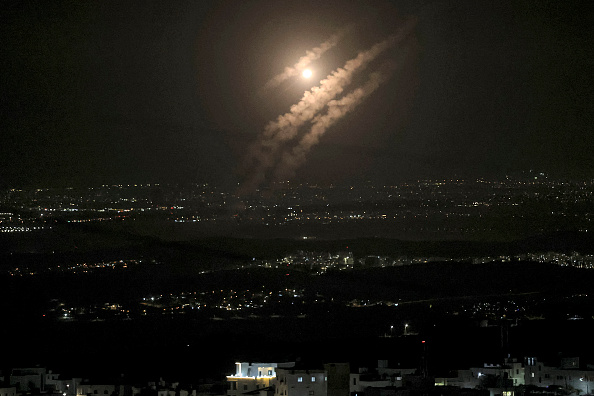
top-left (274, 63), bottom-right (395, 180)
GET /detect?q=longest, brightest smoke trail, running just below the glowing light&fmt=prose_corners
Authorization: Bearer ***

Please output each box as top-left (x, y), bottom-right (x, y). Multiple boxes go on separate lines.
top-left (240, 21), bottom-right (414, 193)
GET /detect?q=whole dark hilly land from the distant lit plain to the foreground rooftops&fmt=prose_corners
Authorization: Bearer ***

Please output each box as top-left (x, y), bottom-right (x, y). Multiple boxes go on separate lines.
top-left (0, 227), bottom-right (594, 381)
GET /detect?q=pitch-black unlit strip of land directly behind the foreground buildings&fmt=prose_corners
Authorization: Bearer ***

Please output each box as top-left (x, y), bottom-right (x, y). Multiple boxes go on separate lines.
top-left (0, 302), bottom-right (594, 382)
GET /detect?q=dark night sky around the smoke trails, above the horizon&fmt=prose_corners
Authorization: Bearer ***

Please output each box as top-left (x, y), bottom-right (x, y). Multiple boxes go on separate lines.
top-left (0, 0), bottom-right (594, 187)
